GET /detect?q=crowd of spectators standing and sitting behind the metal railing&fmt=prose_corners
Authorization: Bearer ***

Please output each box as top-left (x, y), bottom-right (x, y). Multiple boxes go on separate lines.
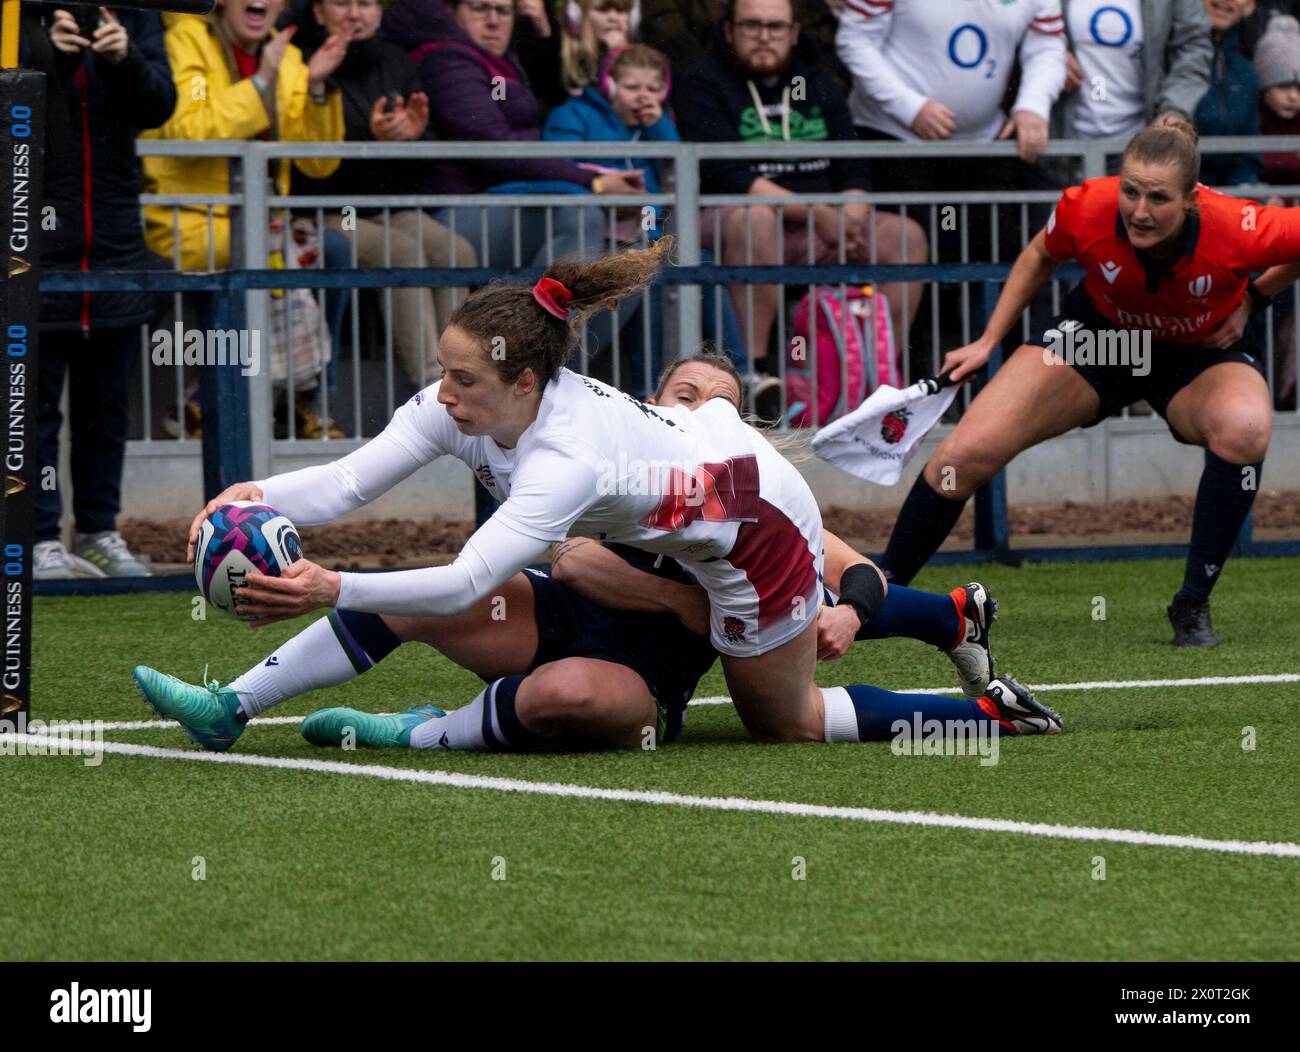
top-left (21, 0), bottom-right (1300, 576)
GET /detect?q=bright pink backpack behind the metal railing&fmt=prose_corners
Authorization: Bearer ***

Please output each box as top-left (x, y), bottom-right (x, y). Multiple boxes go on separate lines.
top-left (785, 285), bottom-right (902, 428)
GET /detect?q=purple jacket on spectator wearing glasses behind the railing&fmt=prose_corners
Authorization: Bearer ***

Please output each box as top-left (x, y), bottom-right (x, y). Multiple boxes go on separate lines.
top-left (382, 0), bottom-right (595, 194)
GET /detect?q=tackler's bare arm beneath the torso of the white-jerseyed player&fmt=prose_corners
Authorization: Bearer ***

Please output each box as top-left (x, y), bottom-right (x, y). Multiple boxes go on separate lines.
top-left (551, 537), bottom-right (709, 636)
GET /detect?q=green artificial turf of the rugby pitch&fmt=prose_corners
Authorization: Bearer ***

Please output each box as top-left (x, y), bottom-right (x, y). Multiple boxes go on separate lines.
top-left (0, 559), bottom-right (1300, 960)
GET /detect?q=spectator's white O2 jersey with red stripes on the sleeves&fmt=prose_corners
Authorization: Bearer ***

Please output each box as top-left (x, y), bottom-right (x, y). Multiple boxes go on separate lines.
top-left (835, 0), bottom-right (1066, 142)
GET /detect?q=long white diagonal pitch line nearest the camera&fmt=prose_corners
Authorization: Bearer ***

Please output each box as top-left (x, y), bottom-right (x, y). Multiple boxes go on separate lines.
top-left (14, 735), bottom-right (1300, 858)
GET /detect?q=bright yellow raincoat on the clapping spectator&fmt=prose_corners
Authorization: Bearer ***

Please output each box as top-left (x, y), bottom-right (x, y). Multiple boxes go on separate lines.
top-left (140, 14), bottom-right (343, 270)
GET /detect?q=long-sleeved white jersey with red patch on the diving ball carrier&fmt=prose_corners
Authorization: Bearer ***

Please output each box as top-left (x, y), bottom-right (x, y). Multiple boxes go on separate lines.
top-left (257, 369), bottom-right (797, 614)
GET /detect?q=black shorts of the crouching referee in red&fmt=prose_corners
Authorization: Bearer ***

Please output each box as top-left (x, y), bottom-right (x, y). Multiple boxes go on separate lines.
top-left (1037, 285), bottom-right (1264, 443)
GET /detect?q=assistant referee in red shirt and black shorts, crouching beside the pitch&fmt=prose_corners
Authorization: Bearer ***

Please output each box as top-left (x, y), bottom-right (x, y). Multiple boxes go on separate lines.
top-left (880, 118), bottom-right (1300, 646)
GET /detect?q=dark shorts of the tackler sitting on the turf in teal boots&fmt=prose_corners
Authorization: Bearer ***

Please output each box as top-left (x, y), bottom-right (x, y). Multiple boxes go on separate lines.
top-left (525, 568), bottom-right (718, 741)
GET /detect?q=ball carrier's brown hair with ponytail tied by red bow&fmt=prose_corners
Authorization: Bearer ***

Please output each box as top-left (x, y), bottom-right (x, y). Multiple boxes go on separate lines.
top-left (447, 235), bottom-right (673, 386)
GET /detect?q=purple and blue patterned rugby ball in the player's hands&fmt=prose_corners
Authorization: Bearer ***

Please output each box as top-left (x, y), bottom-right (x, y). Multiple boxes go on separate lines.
top-left (194, 501), bottom-right (303, 620)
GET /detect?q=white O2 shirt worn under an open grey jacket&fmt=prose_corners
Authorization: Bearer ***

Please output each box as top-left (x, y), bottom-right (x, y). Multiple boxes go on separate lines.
top-left (1066, 0), bottom-right (1147, 139)
